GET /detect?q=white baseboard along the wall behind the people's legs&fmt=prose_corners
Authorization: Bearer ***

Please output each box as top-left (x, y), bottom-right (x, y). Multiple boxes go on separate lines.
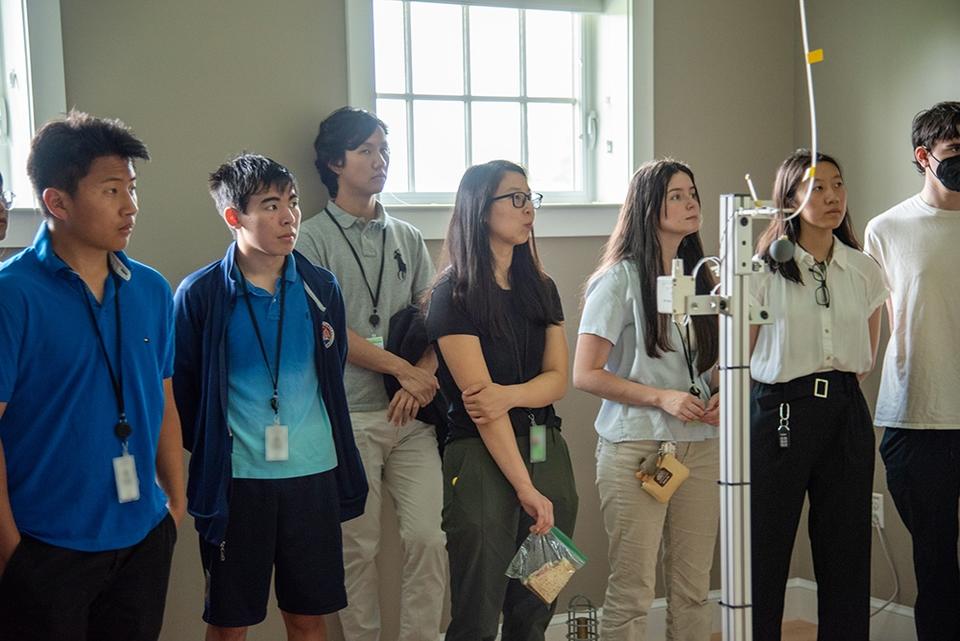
top-left (546, 578), bottom-right (917, 641)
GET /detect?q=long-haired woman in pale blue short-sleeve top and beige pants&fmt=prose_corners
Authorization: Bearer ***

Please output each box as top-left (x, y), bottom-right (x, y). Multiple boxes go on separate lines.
top-left (573, 160), bottom-right (719, 641)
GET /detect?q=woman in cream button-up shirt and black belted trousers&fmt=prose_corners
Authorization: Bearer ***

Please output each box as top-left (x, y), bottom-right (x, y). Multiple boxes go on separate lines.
top-left (750, 149), bottom-right (887, 641)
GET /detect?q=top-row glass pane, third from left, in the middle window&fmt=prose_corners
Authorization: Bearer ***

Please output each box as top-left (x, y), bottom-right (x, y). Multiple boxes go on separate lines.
top-left (470, 7), bottom-right (520, 96)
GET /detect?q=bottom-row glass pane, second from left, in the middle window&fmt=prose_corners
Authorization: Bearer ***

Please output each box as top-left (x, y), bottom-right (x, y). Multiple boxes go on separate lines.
top-left (413, 100), bottom-right (466, 192)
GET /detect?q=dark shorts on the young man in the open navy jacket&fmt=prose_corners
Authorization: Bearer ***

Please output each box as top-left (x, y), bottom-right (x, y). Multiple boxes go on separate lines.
top-left (200, 470), bottom-right (347, 627)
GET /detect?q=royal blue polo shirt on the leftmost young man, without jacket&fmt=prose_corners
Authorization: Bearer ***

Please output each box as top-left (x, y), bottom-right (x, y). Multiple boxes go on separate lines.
top-left (0, 224), bottom-right (174, 552)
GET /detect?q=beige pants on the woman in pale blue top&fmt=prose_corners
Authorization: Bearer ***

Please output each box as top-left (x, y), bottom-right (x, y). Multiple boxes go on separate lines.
top-left (597, 438), bottom-right (720, 641)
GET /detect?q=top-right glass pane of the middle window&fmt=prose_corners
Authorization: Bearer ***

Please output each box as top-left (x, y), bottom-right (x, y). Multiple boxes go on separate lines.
top-left (526, 11), bottom-right (577, 98)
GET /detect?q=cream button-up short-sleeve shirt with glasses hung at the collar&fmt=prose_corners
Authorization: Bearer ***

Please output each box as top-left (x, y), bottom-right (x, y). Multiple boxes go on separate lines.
top-left (750, 240), bottom-right (888, 383)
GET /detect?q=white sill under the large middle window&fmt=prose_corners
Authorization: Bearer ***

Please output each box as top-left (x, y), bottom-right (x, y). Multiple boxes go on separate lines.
top-left (386, 203), bottom-right (620, 240)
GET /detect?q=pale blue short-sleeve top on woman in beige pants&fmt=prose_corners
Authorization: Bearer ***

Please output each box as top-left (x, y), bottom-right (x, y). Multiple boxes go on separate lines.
top-left (579, 260), bottom-right (717, 443)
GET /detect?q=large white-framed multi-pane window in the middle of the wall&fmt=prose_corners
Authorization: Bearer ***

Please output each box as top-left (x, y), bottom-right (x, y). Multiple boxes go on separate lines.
top-left (345, 0), bottom-right (632, 204)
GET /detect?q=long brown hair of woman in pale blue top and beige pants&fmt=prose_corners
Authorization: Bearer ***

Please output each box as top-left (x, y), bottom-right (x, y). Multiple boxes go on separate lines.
top-left (590, 158), bottom-right (719, 372)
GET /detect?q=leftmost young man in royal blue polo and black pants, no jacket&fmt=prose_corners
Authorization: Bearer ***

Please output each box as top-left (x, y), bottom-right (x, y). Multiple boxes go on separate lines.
top-left (0, 112), bottom-right (185, 641)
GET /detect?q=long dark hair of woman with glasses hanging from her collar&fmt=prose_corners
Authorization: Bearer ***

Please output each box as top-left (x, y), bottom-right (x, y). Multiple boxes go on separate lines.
top-left (757, 149), bottom-right (863, 285)
